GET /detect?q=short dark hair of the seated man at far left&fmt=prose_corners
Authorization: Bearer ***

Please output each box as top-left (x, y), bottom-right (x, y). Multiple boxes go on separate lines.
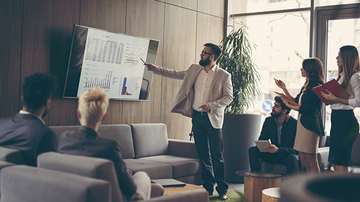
top-left (23, 73), bottom-right (55, 110)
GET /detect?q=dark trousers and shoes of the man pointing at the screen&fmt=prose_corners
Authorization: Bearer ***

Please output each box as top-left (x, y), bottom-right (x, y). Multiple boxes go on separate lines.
top-left (192, 110), bottom-right (229, 193)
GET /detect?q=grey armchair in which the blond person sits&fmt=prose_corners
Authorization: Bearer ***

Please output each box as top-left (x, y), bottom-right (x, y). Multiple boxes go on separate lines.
top-left (38, 152), bottom-right (209, 202)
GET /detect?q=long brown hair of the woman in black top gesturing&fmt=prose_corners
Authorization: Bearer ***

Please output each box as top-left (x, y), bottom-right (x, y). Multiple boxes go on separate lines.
top-left (302, 57), bottom-right (325, 93)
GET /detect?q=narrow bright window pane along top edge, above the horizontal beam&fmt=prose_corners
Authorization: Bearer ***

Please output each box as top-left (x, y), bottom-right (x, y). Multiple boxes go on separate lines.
top-left (230, 0), bottom-right (311, 14)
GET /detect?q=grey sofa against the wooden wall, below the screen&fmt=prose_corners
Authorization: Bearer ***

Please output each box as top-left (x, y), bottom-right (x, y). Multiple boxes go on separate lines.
top-left (50, 123), bottom-right (202, 185)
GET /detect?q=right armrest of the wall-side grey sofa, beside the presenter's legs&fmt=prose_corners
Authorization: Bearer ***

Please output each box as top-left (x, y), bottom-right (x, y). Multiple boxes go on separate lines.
top-left (169, 139), bottom-right (198, 158)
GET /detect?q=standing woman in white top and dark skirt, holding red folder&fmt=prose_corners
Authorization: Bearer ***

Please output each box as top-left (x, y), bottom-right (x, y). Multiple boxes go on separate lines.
top-left (321, 46), bottom-right (360, 172)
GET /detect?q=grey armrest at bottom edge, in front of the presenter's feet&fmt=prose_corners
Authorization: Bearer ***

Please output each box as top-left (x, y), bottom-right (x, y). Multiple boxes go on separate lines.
top-left (144, 189), bottom-right (209, 202)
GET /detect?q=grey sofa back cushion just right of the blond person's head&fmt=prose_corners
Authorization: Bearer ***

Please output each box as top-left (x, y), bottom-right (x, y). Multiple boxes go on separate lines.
top-left (98, 124), bottom-right (135, 159)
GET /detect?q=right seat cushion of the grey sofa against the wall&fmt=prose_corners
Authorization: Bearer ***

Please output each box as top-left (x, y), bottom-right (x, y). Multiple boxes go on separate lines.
top-left (144, 155), bottom-right (201, 178)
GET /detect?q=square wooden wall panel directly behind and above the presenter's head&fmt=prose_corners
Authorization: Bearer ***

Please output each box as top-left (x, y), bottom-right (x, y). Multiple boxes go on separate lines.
top-left (196, 13), bottom-right (224, 64)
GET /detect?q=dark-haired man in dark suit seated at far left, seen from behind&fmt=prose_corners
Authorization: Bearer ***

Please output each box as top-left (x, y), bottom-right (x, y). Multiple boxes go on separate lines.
top-left (0, 73), bottom-right (57, 166)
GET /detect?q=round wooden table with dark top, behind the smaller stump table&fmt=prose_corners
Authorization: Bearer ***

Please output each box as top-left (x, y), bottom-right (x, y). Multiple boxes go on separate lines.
top-left (236, 171), bottom-right (281, 202)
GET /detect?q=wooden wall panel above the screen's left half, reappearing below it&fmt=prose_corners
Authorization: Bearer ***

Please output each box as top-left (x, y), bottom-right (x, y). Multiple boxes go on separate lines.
top-left (80, 0), bottom-right (126, 123)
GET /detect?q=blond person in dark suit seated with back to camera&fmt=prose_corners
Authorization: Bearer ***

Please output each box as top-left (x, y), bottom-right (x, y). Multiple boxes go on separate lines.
top-left (59, 87), bottom-right (151, 200)
